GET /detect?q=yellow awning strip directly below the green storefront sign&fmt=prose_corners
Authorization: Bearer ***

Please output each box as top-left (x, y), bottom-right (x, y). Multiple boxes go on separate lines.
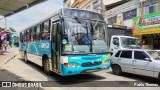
top-left (133, 28), bottom-right (160, 35)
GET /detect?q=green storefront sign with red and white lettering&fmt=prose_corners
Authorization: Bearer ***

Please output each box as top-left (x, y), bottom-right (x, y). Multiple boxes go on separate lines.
top-left (133, 12), bottom-right (160, 30)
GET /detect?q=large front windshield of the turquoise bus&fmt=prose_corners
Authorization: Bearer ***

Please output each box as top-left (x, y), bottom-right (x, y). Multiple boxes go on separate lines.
top-left (62, 18), bottom-right (108, 54)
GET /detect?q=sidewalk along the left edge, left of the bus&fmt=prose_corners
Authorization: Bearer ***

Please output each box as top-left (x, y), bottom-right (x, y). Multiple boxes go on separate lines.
top-left (0, 47), bottom-right (42, 90)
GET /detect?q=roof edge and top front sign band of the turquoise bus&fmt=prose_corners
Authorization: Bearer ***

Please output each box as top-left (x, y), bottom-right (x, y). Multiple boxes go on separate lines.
top-left (21, 8), bottom-right (104, 32)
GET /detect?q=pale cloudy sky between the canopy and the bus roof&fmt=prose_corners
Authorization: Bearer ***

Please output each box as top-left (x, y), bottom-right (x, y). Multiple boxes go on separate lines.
top-left (0, 0), bottom-right (63, 32)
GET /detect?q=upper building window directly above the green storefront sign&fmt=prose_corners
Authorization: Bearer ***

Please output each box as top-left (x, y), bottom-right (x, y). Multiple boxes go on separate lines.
top-left (144, 3), bottom-right (158, 14)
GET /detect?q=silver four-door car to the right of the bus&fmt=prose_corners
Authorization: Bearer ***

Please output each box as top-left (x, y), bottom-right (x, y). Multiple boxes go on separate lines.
top-left (111, 49), bottom-right (160, 80)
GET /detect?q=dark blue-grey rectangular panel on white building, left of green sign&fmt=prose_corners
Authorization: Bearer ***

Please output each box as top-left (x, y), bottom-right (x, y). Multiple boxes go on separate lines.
top-left (123, 9), bottom-right (137, 20)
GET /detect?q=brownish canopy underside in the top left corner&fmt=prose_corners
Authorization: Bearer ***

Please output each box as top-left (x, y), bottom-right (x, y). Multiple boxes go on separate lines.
top-left (0, 0), bottom-right (46, 17)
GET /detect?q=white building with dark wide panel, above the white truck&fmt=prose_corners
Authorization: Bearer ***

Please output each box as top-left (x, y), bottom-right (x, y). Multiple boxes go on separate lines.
top-left (105, 0), bottom-right (140, 29)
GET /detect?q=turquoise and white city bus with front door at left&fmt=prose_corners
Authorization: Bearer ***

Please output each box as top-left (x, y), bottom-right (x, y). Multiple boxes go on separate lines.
top-left (19, 8), bottom-right (110, 76)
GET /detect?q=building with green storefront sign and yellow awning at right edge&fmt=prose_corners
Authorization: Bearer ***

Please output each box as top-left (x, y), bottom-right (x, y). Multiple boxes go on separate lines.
top-left (133, 0), bottom-right (160, 49)
